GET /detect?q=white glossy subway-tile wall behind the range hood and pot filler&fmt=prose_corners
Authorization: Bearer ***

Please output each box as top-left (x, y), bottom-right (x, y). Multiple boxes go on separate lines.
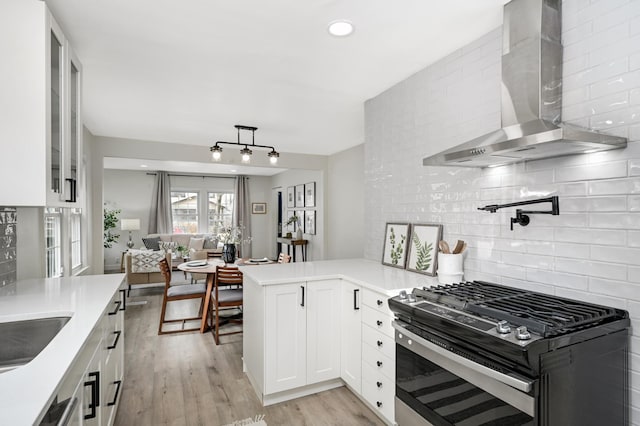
top-left (365, 0), bottom-right (640, 425)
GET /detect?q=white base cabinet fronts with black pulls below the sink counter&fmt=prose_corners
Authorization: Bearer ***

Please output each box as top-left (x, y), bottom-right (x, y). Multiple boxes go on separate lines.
top-left (43, 290), bottom-right (125, 425)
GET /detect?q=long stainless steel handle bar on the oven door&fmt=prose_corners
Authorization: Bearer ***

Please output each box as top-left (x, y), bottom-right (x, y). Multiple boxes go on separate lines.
top-left (393, 321), bottom-right (533, 392)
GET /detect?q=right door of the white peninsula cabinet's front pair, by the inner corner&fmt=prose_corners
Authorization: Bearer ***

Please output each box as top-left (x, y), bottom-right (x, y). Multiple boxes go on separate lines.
top-left (307, 280), bottom-right (341, 384)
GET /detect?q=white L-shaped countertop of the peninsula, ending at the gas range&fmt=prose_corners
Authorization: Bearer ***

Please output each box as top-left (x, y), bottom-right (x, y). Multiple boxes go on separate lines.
top-left (241, 259), bottom-right (438, 296)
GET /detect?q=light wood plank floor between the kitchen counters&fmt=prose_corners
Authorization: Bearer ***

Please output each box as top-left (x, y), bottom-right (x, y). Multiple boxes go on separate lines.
top-left (115, 280), bottom-right (384, 426)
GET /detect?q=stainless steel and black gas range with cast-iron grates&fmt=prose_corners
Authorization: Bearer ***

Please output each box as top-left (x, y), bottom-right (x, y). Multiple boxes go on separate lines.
top-left (389, 281), bottom-right (630, 426)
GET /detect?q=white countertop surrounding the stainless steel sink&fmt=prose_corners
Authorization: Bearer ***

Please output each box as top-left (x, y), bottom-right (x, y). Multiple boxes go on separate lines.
top-left (0, 274), bottom-right (124, 425)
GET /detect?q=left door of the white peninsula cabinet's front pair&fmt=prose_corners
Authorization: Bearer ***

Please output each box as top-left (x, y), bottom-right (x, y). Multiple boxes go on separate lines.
top-left (265, 283), bottom-right (307, 394)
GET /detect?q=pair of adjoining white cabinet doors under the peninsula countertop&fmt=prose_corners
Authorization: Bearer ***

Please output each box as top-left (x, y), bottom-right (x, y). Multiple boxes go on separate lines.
top-left (264, 280), bottom-right (340, 394)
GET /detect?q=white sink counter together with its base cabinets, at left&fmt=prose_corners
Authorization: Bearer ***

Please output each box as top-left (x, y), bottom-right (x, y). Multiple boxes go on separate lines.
top-left (0, 274), bottom-right (124, 425)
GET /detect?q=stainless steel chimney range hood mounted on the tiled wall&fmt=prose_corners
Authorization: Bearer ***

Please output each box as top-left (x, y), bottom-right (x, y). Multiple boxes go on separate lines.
top-left (422, 0), bottom-right (627, 167)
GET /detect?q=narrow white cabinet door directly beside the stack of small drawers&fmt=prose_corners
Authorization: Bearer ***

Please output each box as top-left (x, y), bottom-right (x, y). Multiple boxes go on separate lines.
top-left (340, 281), bottom-right (362, 393)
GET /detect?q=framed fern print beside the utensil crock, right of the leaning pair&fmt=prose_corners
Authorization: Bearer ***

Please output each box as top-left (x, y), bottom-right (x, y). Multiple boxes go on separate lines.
top-left (407, 223), bottom-right (442, 276)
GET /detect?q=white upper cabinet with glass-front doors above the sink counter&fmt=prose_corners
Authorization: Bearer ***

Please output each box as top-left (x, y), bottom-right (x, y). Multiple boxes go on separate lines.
top-left (0, 0), bottom-right (82, 207)
